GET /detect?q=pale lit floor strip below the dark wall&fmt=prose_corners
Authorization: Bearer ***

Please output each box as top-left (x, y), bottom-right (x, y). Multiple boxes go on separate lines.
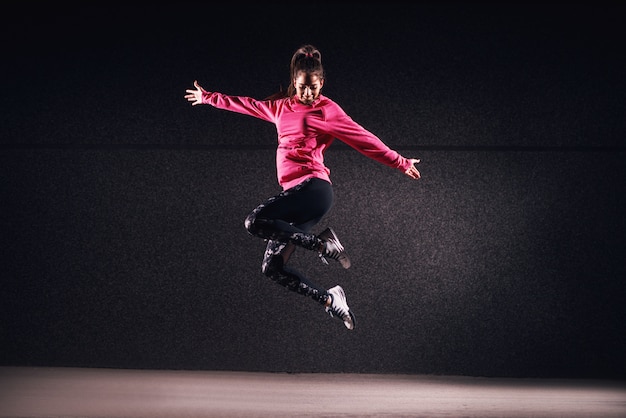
top-left (0, 367), bottom-right (626, 418)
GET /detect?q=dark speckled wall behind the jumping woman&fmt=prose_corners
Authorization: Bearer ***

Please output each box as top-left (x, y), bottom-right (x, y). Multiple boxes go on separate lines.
top-left (0, 3), bottom-right (626, 379)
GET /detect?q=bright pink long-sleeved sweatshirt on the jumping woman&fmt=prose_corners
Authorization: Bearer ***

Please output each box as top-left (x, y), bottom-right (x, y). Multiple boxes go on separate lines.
top-left (202, 92), bottom-right (411, 190)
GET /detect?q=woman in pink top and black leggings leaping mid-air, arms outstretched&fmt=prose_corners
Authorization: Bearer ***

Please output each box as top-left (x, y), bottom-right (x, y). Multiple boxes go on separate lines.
top-left (185, 45), bottom-right (420, 329)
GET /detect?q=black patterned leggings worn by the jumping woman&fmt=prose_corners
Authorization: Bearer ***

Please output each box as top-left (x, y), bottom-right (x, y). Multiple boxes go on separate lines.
top-left (244, 178), bottom-right (333, 304)
